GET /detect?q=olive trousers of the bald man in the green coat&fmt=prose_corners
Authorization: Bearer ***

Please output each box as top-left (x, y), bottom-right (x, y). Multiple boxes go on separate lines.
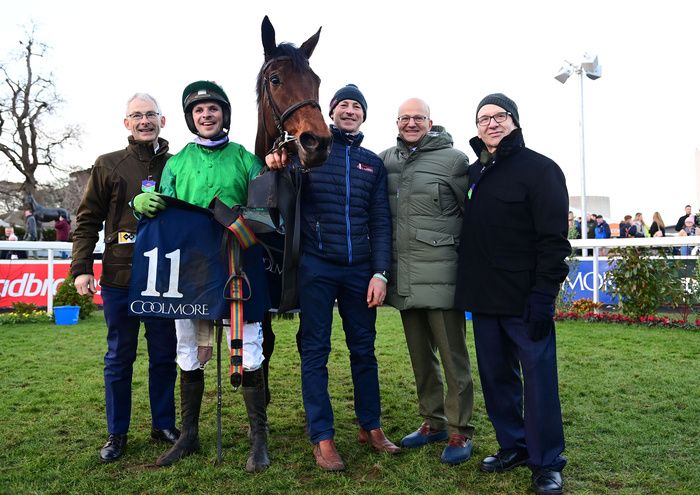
top-left (401, 309), bottom-right (474, 438)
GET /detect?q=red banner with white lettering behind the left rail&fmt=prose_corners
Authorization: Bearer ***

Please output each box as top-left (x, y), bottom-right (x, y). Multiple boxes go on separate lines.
top-left (0, 260), bottom-right (102, 308)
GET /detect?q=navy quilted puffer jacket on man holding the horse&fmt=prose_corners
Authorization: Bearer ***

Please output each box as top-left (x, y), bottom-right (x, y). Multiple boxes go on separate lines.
top-left (301, 126), bottom-right (391, 273)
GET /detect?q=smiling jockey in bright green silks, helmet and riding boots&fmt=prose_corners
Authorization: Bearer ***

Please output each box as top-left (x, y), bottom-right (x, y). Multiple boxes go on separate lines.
top-left (134, 81), bottom-right (270, 472)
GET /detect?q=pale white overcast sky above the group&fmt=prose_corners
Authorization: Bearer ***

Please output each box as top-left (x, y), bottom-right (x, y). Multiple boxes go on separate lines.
top-left (0, 0), bottom-right (700, 224)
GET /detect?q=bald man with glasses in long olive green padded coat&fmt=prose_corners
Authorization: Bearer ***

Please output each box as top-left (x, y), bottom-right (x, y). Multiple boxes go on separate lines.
top-left (380, 98), bottom-right (474, 464)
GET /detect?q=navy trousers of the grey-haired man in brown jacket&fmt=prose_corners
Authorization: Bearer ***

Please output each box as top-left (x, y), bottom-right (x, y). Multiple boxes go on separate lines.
top-left (102, 286), bottom-right (177, 434)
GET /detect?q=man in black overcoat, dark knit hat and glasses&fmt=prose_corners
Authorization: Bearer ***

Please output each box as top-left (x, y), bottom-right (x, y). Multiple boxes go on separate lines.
top-left (455, 93), bottom-right (571, 495)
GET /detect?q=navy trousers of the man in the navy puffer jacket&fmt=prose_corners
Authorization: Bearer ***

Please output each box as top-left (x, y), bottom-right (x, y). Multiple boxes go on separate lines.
top-left (299, 255), bottom-right (381, 443)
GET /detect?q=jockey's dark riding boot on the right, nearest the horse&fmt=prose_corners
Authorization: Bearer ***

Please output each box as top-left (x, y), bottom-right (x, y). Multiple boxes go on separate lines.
top-left (243, 368), bottom-right (270, 473)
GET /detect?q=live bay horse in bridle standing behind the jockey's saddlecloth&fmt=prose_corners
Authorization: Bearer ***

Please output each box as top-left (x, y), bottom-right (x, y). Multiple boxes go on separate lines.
top-left (248, 16), bottom-right (331, 402)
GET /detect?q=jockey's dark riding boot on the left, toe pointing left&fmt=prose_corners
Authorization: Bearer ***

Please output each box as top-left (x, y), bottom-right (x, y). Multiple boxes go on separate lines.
top-left (156, 369), bottom-right (204, 466)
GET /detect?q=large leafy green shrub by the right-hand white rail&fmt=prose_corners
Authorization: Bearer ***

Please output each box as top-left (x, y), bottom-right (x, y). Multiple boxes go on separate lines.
top-left (608, 248), bottom-right (685, 318)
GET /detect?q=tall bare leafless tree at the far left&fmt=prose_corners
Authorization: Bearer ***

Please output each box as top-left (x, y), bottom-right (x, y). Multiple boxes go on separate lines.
top-left (0, 28), bottom-right (80, 193)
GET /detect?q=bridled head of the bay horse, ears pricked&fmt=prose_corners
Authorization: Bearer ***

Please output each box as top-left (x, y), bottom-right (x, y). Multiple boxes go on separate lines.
top-left (255, 16), bottom-right (331, 167)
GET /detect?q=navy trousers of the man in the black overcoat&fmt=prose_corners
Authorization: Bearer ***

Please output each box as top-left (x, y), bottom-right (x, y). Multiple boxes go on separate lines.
top-left (473, 313), bottom-right (566, 471)
